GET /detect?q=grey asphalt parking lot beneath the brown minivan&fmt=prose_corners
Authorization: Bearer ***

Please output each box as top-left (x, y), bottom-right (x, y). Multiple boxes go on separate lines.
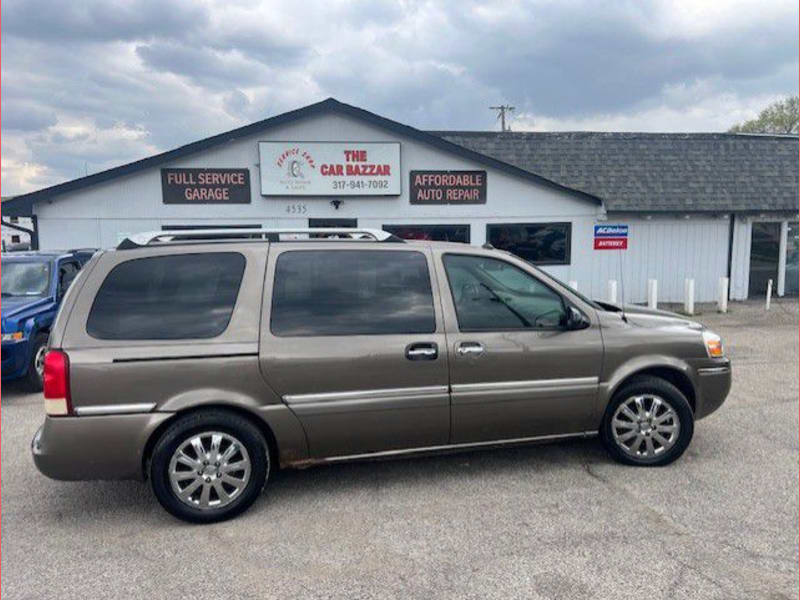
top-left (0, 302), bottom-right (798, 600)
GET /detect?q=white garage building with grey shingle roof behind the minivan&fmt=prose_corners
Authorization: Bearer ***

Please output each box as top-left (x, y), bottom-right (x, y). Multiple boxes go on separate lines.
top-left (2, 99), bottom-right (798, 302)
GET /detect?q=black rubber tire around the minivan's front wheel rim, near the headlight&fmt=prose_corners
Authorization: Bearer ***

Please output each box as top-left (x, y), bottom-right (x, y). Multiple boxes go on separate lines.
top-left (600, 376), bottom-right (694, 467)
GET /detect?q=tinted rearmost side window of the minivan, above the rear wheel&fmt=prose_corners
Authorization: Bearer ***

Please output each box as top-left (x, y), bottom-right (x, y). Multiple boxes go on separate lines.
top-left (86, 252), bottom-right (245, 340)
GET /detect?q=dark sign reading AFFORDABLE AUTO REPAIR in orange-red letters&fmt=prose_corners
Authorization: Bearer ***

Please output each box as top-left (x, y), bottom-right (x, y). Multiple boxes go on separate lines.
top-left (409, 171), bottom-right (486, 204)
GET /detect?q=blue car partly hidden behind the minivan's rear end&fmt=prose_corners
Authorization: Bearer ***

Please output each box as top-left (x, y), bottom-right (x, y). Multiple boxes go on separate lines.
top-left (0, 250), bottom-right (94, 392)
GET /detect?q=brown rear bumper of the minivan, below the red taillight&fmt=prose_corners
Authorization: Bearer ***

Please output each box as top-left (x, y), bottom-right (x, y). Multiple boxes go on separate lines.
top-left (31, 413), bottom-right (173, 481)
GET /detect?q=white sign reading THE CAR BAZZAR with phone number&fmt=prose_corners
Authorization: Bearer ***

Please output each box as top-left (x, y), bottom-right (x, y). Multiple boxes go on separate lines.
top-left (258, 142), bottom-right (400, 196)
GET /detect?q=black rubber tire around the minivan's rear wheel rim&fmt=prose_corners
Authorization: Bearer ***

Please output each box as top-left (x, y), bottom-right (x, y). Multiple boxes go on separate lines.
top-left (150, 409), bottom-right (272, 523)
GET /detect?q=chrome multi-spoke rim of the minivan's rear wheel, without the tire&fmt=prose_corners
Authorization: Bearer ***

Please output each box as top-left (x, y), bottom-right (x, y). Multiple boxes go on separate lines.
top-left (169, 431), bottom-right (252, 510)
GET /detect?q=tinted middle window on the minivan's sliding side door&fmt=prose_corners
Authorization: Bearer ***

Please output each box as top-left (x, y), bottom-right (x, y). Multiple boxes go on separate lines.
top-left (270, 250), bottom-right (436, 336)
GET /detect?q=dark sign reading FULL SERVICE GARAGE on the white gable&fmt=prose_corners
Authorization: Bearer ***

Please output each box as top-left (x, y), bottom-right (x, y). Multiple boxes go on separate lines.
top-left (161, 169), bottom-right (250, 204)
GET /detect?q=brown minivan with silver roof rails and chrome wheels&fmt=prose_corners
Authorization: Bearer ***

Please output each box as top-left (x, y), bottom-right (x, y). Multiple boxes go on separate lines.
top-left (33, 229), bottom-right (731, 522)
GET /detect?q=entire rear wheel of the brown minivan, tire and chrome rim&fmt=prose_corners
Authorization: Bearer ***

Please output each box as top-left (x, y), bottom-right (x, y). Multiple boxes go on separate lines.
top-left (150, 410), bottom-right (271, 523)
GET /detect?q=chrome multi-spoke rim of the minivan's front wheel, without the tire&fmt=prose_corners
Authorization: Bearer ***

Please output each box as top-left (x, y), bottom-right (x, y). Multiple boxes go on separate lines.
top-left (611, 394), bottom-right (681, 460)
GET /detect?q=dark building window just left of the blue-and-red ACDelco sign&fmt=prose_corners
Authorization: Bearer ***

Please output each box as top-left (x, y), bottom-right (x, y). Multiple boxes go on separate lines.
top-left (486, 223), bottom-right (572, 265)
